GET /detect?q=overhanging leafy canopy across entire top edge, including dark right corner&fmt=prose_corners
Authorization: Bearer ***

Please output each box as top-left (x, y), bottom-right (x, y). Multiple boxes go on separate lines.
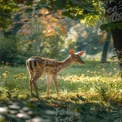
top-left (0, 0), bottom-right (122, 30)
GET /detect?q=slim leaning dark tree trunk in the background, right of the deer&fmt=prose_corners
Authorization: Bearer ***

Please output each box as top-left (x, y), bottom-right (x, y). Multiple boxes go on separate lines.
top-left (101, 33), bottom-right (111, 63)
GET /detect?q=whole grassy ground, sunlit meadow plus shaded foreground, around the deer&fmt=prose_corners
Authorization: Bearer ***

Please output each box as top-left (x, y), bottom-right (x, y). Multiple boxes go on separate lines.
top-left (0, 61), bottom-right (122, 122)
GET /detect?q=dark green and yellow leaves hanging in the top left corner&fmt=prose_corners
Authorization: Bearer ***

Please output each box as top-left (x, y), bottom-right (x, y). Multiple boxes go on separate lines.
top-left (0, 0), bottom-right (33, 29)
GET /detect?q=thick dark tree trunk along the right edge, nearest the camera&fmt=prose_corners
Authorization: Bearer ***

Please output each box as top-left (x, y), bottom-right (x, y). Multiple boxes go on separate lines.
top-left (102, 0), bottom-right (122, 77)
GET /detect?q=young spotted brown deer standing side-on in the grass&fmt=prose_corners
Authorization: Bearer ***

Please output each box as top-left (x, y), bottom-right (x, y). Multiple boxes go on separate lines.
top-left (26, 49), bottom-right (84, 96)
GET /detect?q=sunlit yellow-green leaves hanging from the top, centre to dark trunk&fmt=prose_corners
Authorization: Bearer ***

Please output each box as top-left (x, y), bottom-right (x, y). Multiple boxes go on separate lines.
top-left (37, 0), bottom-right (103, 25)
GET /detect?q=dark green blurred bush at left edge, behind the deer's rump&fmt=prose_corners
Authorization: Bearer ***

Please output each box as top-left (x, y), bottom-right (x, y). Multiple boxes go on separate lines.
top-left (0, 36), bottom-right (32, 65)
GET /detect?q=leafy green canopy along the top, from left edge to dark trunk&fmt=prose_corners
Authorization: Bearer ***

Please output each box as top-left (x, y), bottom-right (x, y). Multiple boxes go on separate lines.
top-left (0, 0), bottom-right (101, 28)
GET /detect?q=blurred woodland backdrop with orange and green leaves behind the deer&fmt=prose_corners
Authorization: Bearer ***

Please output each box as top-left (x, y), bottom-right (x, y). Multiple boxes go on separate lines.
top-left (0, 0), bottom-right (115, 65)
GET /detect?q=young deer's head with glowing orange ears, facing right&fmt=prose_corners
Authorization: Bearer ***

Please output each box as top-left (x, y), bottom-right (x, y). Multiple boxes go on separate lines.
top-left (69, 49), bottom-right (85, 64)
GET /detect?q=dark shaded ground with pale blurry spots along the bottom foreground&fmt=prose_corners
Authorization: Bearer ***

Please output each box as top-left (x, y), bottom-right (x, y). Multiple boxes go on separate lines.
top-left (0, 95), bottom-right (122, 122)
